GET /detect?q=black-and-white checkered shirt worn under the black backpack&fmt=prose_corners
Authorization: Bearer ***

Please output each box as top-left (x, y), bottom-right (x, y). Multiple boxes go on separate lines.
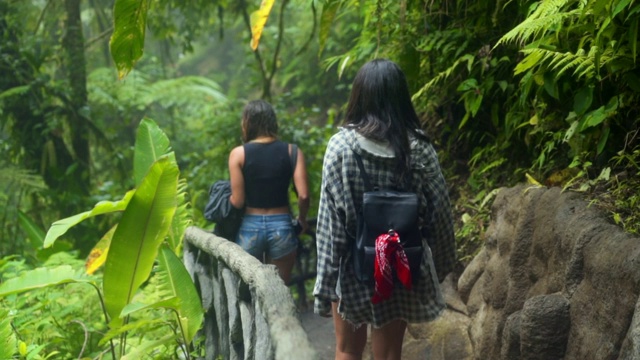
top-left (313, 129), bottom-right (456, 327)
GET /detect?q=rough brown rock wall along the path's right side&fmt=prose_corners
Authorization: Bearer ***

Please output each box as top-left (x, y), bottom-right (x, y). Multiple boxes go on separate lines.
top-left (405, 185), bottom-right (640, 360)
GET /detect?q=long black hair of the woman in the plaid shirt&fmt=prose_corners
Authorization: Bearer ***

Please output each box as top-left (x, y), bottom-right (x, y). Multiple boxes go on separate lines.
top-left (344, 59), bottom-right (427, 186)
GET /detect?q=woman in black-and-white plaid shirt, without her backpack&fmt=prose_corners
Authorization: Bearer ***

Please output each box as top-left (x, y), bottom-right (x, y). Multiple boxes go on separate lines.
top-left (313, 59), bottom-right (455, 360)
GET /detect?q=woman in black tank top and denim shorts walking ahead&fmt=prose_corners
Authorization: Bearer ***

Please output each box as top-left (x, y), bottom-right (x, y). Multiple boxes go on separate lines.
top-left (229, 100), bottom-right (309, 284)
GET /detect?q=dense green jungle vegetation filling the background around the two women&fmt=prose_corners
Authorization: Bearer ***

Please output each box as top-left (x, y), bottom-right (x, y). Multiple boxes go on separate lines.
top-left (0, 0), bottom-right (640, 359)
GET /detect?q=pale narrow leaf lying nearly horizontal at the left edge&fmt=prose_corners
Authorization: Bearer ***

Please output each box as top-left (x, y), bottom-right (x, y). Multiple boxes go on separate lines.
top-left (0, 265), bottom-right (93, 297)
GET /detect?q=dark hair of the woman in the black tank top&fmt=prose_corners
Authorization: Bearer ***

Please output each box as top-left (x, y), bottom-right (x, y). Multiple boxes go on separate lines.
top-left (242, 100), bottom-right (278, 142)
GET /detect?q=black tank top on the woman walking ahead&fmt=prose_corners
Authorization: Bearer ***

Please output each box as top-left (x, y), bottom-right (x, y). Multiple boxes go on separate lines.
top-left (242, 140), bottom-right (293, 208)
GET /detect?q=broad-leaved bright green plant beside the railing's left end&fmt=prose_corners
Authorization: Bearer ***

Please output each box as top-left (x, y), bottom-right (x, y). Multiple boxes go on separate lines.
top-left (0, 119), bottom-right (203, 359)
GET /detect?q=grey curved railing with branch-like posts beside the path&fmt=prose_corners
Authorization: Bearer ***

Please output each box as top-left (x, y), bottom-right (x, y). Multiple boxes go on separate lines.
top-left (184, 227), bottom-right (317, 360)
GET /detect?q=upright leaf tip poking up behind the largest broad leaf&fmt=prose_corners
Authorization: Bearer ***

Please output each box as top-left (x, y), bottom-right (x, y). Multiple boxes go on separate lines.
top-left (133, 118), bottom-right (175, 185)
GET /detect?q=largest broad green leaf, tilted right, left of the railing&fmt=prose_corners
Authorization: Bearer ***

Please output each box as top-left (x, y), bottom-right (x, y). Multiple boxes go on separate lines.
top-left (103, 157), bottom-right (179, 327)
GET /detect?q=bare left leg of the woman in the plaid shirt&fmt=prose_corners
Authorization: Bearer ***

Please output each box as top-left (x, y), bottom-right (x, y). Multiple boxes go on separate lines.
top-left (331, 303), bottom-right (367, 360)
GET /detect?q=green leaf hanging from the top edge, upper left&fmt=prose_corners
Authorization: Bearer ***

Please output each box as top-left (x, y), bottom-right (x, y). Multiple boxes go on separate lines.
top-left (109, 0), bottom-right (149, 79)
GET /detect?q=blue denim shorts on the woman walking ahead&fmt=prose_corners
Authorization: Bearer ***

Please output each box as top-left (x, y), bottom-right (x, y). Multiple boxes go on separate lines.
top-left (236, 214), bottom-right (298, 261)
